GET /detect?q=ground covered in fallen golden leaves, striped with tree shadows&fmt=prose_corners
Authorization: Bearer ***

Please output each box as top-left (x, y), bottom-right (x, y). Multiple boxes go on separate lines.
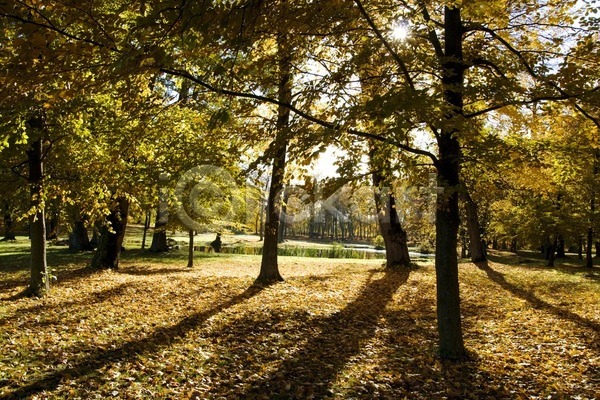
top-left (0, 239), bottom-right (600, 399)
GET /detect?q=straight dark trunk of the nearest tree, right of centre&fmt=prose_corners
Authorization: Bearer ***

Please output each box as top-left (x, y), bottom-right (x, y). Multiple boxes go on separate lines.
top-left (435, 6), bottom-right (466, 359)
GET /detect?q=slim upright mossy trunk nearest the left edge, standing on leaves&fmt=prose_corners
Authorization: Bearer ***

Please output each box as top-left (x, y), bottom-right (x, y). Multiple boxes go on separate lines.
top-left (27, 138), bottom-right (50, 296)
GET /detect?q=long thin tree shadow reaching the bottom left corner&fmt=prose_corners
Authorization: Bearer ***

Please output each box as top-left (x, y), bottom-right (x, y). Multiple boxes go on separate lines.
top-left (0, 285), bottom-right (265, 399)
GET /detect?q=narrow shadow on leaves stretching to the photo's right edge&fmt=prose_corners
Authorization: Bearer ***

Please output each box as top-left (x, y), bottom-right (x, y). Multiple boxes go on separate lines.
top-left (475, 261), bottom-right (600, 338)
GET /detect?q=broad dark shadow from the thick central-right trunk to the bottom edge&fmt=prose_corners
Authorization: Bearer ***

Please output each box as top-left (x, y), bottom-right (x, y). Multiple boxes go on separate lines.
top-left (240, 270), bottom-right (409, 399)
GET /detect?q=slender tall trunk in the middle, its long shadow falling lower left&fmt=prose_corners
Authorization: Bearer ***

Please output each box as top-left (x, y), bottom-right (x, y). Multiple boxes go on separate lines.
top-left (256, 28), bottom-right (292, 283)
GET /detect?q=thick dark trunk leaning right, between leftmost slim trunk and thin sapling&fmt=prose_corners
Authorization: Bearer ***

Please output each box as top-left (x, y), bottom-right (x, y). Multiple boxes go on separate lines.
top-left (90, 197), bottom-right (129, 269)
